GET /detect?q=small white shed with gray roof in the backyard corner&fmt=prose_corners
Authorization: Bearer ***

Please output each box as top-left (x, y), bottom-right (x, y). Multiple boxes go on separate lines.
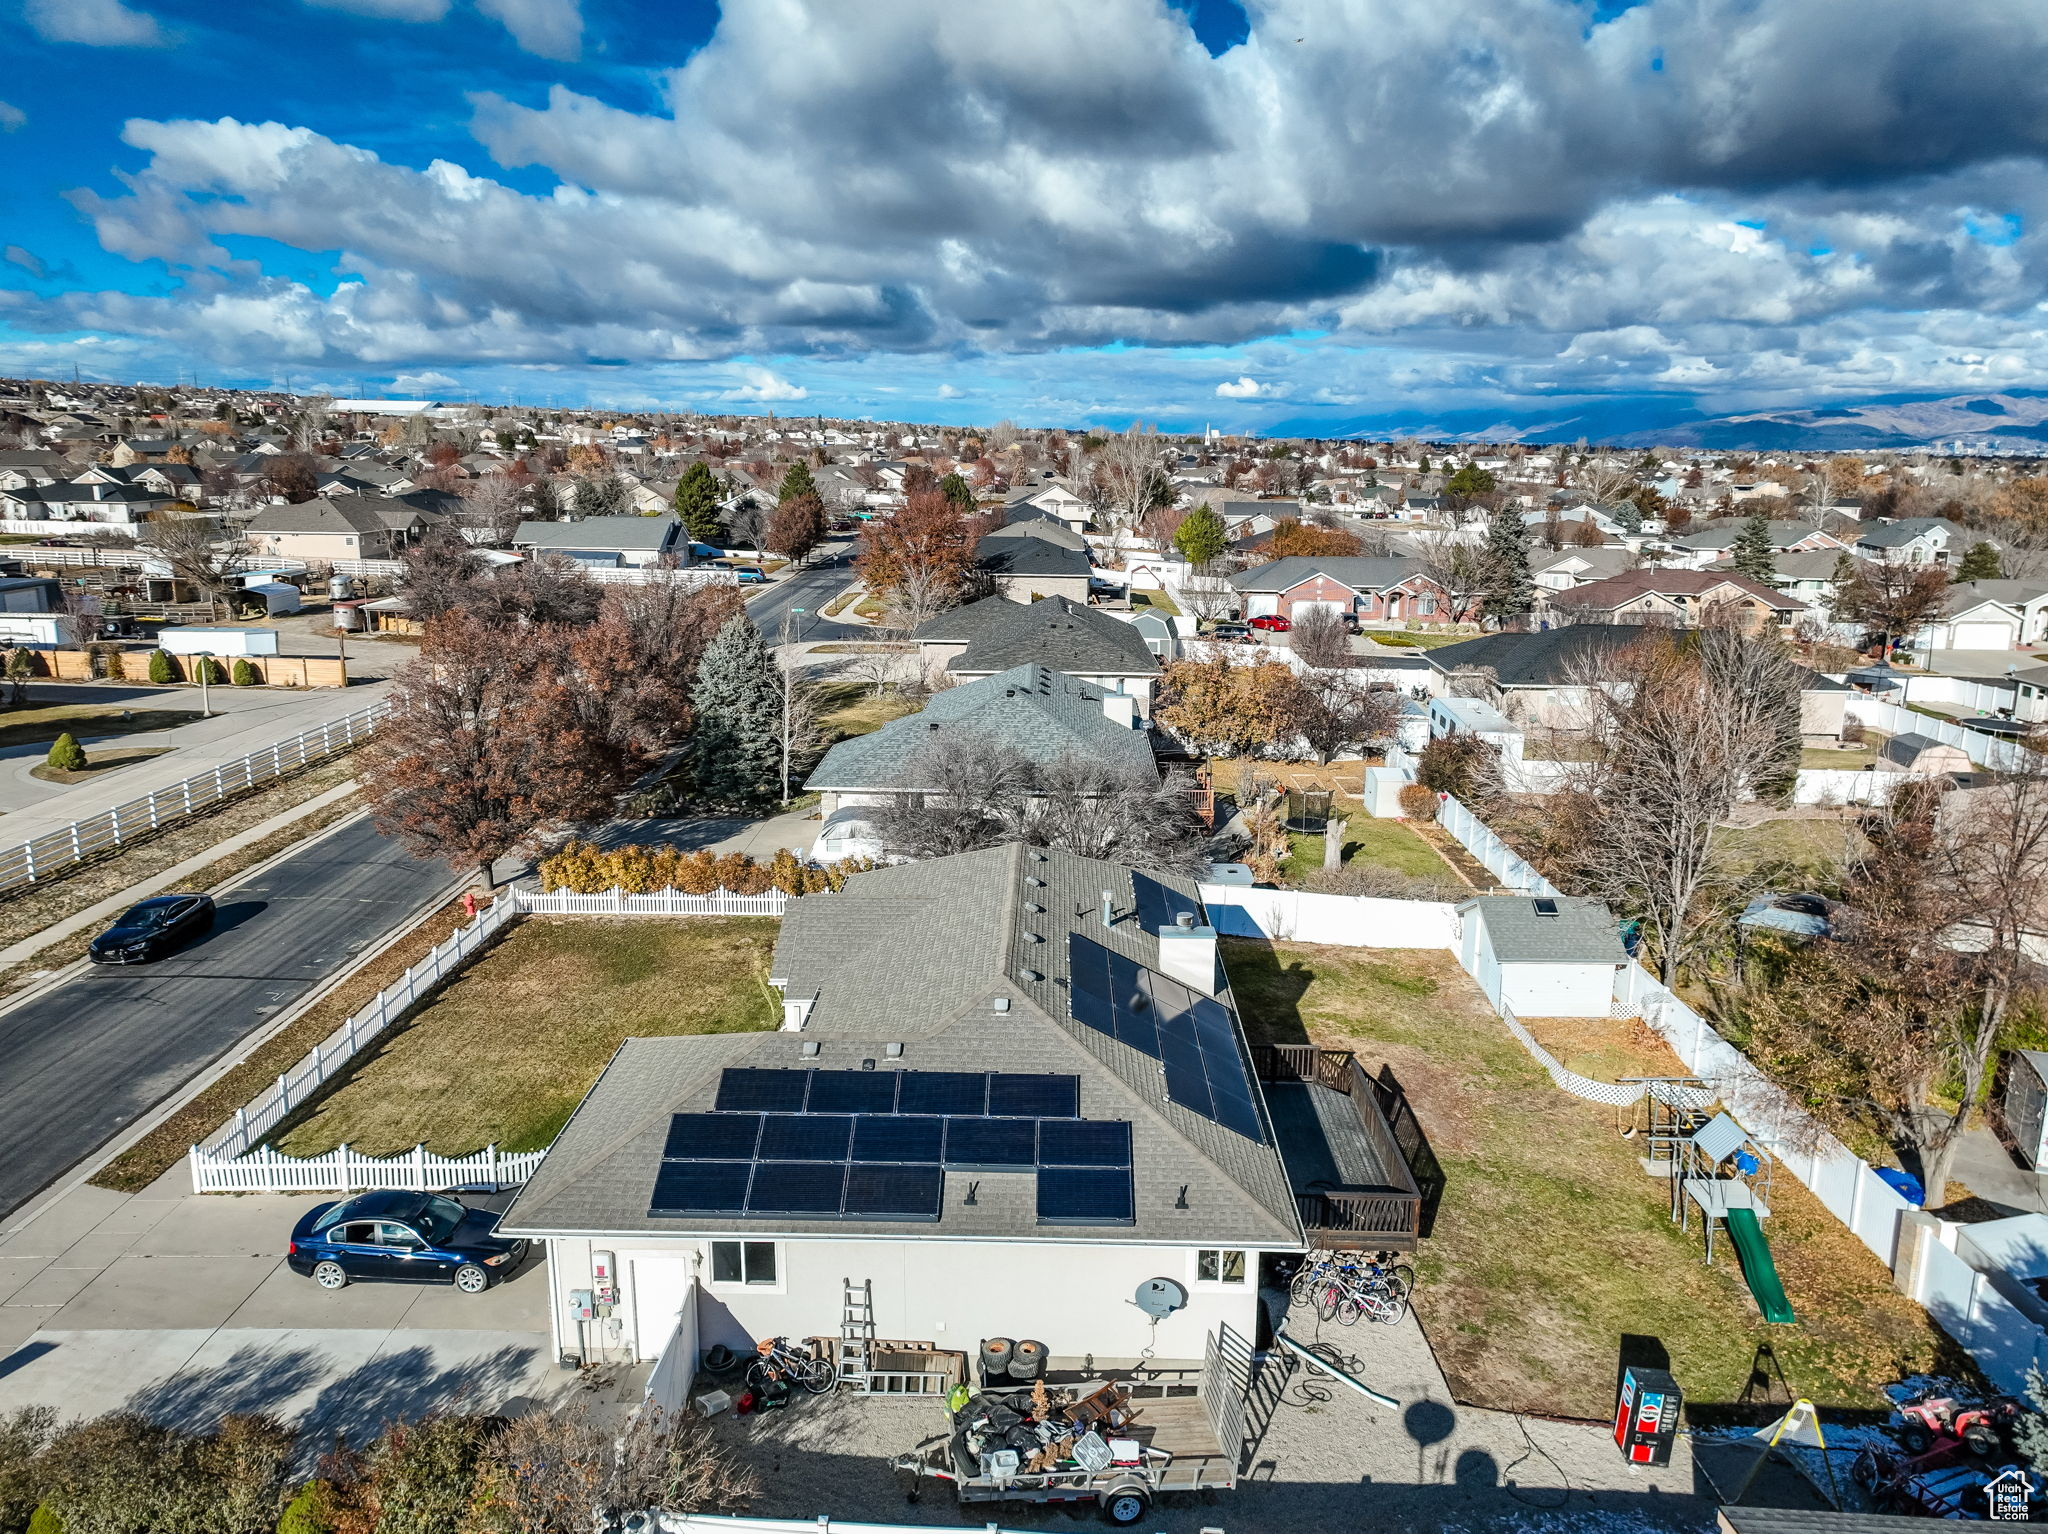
top-left (1458, 895), bottom-right (1628, 1018)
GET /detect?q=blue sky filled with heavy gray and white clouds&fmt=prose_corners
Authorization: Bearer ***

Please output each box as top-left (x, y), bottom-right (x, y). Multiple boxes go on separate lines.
top-left (0, 0), bottom-right (2048, 436)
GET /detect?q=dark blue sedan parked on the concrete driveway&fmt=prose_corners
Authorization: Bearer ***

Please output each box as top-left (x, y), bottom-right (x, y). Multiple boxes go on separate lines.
top-left (285, 1190), bottom-right (526, 1294)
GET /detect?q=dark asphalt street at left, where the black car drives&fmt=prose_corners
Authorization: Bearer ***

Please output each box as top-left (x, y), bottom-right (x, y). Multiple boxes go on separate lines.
top-left (0, 819), bottom-right (455, 1215)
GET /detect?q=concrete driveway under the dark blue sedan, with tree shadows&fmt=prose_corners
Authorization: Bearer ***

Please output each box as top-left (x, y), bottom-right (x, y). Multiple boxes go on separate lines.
top-left (0, 1165), bottom-right (557, 1442)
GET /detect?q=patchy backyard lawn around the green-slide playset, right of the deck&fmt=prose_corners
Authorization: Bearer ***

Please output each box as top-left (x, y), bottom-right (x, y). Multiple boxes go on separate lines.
top-left (1225, 940), bottom-right (1970, 1421)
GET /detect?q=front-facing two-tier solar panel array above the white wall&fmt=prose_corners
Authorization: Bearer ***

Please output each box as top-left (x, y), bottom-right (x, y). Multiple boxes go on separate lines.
top-left (647, 1067), bottom-right (1135, 1225)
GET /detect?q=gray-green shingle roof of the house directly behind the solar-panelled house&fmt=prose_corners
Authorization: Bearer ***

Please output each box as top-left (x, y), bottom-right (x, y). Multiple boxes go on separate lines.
top-left (803, 666), bottom-right (1157, 793)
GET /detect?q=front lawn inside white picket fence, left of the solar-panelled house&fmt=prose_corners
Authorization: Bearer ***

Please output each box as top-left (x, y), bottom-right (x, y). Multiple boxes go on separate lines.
top-left (274, 915), bottom-right (780, 1155)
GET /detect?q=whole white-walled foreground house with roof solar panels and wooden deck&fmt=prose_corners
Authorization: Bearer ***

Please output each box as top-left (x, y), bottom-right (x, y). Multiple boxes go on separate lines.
top-left (502, 846), bottom-right (1417, 1366)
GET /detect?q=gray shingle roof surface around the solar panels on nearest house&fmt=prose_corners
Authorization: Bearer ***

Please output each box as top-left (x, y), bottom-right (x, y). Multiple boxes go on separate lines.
top-left (504, 846), bottom-right (1300, 1247)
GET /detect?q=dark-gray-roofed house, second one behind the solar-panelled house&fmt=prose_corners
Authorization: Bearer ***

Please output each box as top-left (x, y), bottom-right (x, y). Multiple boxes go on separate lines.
top-left (911, 596), bottom-right (1159, 721)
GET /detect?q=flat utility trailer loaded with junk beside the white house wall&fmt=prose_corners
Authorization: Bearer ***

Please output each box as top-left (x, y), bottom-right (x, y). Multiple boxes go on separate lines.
top-left (893, 1327), bottom-right (1251, 1526)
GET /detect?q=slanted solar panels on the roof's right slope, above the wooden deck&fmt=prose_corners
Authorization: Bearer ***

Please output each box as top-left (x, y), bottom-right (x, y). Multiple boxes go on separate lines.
top-left (1067, 932), bottom-right (1266, 1145)
